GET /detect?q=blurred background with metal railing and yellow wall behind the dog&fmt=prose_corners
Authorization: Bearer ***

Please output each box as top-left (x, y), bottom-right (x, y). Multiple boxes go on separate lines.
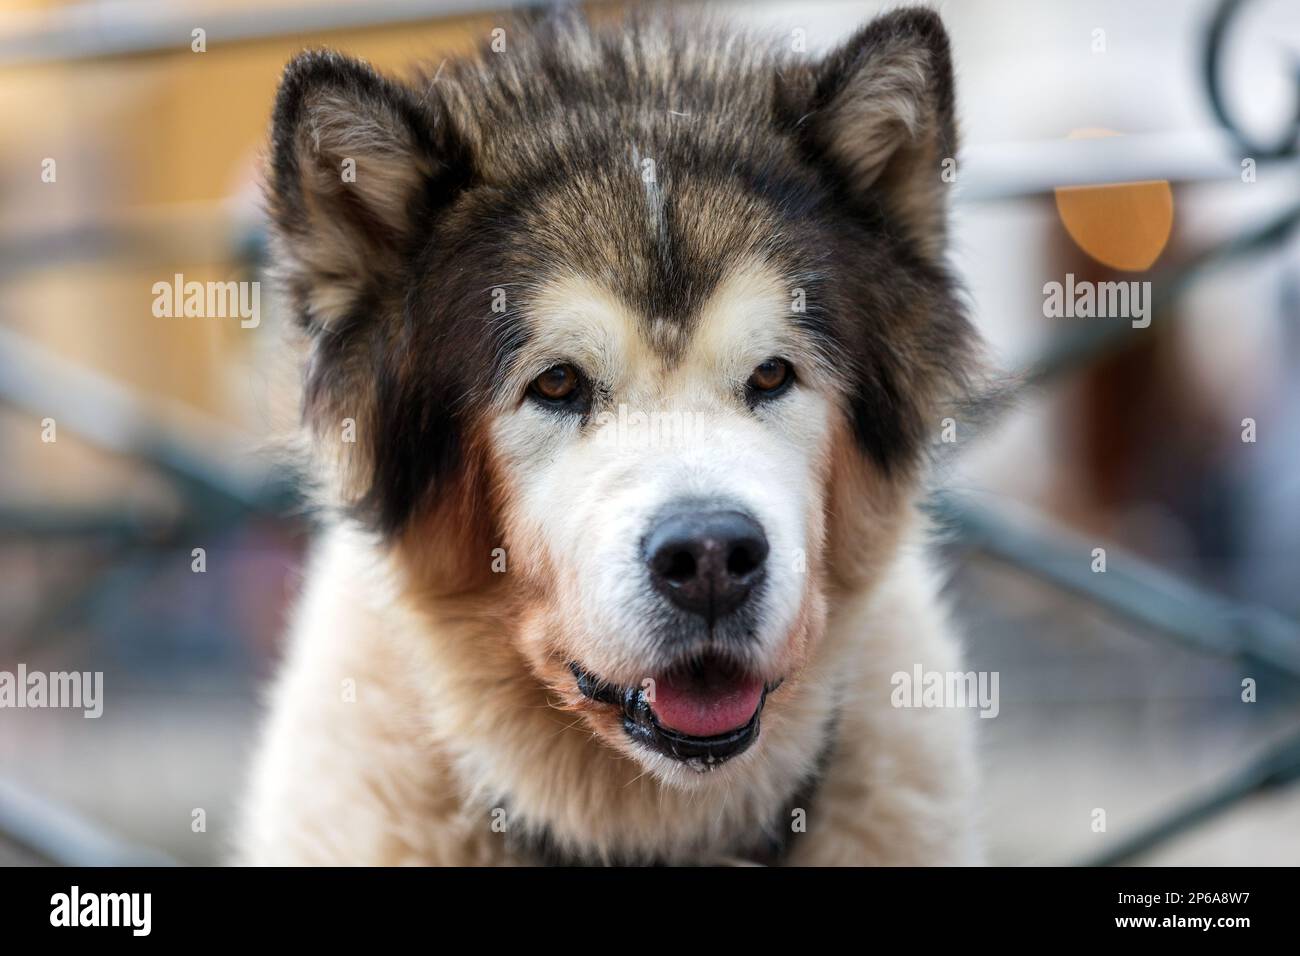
top-left (0, 0), bottom-right (1300, 865)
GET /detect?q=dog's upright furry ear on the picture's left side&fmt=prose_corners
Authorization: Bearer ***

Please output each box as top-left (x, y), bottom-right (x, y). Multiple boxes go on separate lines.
top-left (269, 51), bottom-right (469, 330)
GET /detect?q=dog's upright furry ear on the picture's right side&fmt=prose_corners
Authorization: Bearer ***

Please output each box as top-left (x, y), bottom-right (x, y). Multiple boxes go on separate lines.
top-left (777, 8), bottom-right (957, 256)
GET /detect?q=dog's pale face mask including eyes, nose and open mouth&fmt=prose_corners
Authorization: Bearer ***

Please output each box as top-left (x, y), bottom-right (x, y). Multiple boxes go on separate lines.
top-left (490, 261), bottom-right (835, 771)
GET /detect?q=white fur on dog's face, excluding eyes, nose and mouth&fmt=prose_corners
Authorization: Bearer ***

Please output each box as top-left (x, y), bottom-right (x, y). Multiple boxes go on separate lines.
top-left (493, 265), bottom-right (831, 687)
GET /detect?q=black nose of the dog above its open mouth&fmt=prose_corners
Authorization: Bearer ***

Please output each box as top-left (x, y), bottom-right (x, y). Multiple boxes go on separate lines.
top-left (645, 511), bottom-right (767, 623)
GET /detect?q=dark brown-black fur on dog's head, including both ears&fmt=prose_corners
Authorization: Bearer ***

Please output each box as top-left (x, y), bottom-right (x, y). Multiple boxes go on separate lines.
top-left (270, 9), bottom-right (972, 546)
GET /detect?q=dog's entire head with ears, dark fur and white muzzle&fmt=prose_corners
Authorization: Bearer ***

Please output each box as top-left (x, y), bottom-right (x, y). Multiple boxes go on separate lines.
top-left (272, 12), bottom-right (970, 784)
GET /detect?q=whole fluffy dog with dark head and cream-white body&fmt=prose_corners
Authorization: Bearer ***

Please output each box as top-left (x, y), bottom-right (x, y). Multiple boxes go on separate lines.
top-left (237, 3), bottom-right (980, 865)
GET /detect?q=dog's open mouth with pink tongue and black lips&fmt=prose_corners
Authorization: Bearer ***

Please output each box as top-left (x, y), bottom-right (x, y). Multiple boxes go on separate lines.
top-left (569, 654), bottom-right (780, 770)
